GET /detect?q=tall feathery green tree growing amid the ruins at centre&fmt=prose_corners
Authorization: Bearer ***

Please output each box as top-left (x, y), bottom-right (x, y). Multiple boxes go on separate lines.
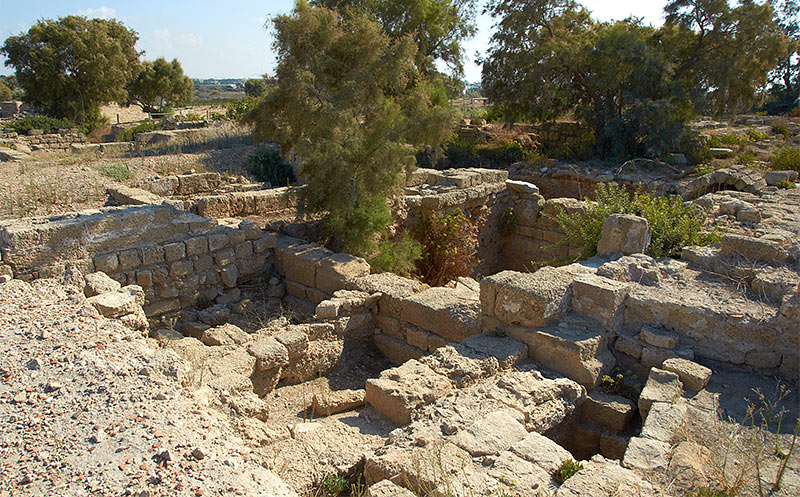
top-left (249, 1), bottom-right (451, 256)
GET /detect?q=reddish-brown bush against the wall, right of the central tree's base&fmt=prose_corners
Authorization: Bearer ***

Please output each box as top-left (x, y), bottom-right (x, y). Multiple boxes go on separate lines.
top-left (417, 210), bottom-right (478, 286)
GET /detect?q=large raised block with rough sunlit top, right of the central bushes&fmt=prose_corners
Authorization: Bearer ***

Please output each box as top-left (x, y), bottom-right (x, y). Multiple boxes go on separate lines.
top-left (480, 267), bottom-right (573, 327)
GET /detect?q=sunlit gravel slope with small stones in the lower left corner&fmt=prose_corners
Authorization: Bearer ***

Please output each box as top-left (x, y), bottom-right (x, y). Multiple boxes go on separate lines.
top-left (0, 280), bottom-right (294, 497)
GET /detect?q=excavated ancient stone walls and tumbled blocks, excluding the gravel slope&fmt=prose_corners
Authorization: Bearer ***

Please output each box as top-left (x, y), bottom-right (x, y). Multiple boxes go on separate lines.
top-left (0, 161), bottom-right (800, 496)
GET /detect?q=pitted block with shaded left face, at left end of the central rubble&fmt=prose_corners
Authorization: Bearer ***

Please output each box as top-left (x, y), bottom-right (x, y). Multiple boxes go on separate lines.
top-left (366, 359), bottom-right (453, 425)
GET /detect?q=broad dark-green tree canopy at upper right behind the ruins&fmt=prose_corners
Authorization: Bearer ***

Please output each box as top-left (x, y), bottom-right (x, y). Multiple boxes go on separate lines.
top-left (482, 0), bottom-right (786, 157)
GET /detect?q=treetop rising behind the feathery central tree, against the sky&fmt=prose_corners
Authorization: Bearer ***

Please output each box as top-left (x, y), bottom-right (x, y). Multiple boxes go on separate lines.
top-left (313, 0), bottom-right (476, 76)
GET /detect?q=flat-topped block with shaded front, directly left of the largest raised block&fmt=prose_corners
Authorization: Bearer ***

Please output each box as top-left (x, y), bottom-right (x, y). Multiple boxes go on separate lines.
top-left (402, 287), bottom-right (481, 342)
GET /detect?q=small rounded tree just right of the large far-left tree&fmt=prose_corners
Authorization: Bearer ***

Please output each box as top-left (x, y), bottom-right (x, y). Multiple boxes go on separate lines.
top-left (128, 57), bottom-right (194, 112)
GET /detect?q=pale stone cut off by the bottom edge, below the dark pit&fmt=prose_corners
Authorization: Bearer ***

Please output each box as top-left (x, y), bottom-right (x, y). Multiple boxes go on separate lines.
top-left (555, 456), bottom-right (658, 497)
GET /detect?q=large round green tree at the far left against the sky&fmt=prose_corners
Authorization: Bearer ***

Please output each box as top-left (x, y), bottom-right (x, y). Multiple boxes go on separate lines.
top-left (0, 16), bottom-right (139, 123)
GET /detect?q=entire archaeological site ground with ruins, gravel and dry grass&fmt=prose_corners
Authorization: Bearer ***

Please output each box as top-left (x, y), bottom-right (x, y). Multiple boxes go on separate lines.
top-left (0, 108), bottom-right (800, 497)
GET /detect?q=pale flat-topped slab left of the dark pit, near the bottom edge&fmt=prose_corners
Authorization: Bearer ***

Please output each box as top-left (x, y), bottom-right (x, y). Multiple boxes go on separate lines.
top-left (451, 409), bottom-right (528, 457)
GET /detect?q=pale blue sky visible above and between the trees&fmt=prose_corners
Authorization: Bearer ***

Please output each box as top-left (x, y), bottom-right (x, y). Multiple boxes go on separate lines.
top-left (0, 0), bottom-right (667, 82)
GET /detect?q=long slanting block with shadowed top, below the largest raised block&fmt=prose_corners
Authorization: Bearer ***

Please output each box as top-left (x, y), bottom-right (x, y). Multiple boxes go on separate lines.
top-left (506, 322), bottom-right (615, 389)
